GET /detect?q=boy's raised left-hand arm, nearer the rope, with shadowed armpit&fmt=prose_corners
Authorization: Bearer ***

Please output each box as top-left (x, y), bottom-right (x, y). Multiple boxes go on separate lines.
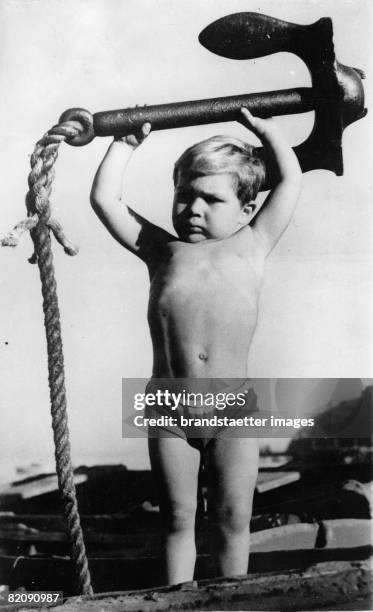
top-left (91, 124), bottom-right (171, 261)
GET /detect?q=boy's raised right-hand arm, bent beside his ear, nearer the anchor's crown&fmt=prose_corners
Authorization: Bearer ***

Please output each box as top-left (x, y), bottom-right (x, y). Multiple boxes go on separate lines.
top-left (241, 108), bottom-right (302, 254)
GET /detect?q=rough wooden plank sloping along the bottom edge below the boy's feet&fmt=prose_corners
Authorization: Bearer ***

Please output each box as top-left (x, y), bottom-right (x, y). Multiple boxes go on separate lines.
top-left (55, 563), bottom-right (372, 612)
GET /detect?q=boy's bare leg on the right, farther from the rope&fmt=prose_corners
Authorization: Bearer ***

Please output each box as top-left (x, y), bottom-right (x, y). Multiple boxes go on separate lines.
top-left (206, 438), bottom-right (259, 576)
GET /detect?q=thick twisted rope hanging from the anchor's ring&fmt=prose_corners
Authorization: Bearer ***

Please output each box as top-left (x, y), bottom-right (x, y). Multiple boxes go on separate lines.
top-left (22, 122), bottom-right (93, 595)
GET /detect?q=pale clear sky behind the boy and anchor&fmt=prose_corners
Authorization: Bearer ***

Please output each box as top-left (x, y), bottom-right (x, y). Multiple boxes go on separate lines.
top-left (0, 0), bottom-right (373, 474)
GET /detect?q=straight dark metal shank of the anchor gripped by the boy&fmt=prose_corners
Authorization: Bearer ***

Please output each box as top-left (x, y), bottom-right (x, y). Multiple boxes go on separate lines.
top-left (93, 87), bottom-right (315, 136)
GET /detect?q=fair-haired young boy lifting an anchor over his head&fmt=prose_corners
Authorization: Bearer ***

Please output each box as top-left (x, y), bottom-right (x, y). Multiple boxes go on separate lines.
top-left (91, 109), bottom-right (302, 584)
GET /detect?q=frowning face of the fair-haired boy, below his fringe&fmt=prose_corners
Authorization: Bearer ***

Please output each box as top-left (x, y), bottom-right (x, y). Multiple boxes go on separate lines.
top-left (172, 173), bottom-right (253, 243)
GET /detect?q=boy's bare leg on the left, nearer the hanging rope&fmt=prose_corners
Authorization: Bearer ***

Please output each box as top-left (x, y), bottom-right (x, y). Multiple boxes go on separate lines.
top-left (149, 437), bottom-right (200, 584)
